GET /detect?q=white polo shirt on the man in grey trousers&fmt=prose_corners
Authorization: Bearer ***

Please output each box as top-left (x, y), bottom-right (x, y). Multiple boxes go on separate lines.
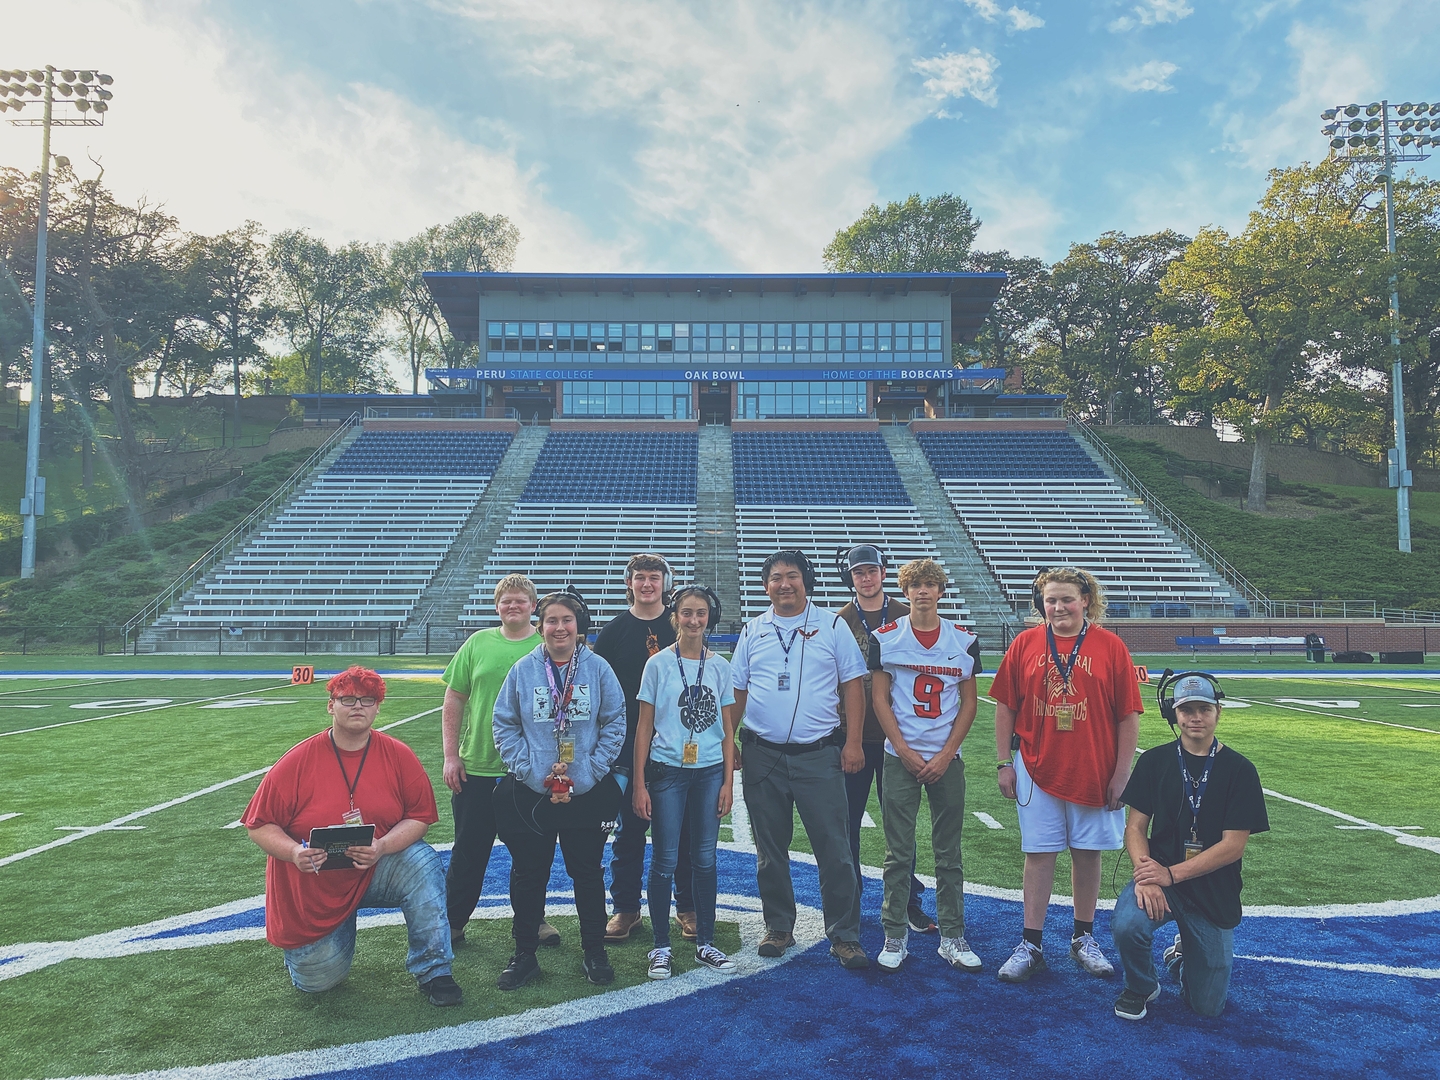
top-left (730, 603), bottom-right (865, 743)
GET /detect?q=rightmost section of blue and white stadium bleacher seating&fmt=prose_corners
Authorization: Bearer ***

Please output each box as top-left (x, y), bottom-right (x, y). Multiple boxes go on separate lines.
top-left (917, 432), bottom-right (1234, 618)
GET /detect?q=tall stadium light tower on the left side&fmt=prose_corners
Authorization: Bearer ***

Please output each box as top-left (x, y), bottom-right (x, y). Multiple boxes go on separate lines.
top-left (0, 66), bottom-right (114, 577)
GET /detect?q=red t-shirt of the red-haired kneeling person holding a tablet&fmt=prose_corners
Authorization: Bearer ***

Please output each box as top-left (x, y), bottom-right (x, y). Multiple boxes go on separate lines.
top-left (240, 729), bottom-right (441, 949)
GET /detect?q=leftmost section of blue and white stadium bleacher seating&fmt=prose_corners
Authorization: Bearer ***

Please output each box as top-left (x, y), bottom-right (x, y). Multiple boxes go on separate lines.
top-left (161, 432), bottom-right (511, 628)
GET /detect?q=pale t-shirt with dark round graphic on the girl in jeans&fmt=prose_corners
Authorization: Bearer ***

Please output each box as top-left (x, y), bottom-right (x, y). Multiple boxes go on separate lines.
top-left (636, 647), bottom-right (734, 769)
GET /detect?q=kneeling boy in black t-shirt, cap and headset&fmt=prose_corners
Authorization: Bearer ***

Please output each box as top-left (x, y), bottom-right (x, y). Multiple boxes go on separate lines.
top-left (1110, 674), bottom-right (1270, 1020)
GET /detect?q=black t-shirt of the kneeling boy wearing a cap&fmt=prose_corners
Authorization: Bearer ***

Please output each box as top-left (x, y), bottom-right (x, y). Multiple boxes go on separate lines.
top-left (1120, 743), bottom-right (1270, 930)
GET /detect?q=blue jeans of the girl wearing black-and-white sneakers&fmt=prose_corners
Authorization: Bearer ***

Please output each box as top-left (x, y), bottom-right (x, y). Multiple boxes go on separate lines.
top-left (647, 763), bottom-right (724, 949)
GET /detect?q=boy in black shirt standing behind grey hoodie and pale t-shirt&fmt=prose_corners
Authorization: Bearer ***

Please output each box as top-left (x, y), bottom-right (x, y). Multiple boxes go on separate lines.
top-left (595, 552), bottom-right (696, 945)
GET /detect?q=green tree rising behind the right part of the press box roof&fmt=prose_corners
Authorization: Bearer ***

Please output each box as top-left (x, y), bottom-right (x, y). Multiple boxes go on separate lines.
top-left (824, 193), bottom-right (981, 274)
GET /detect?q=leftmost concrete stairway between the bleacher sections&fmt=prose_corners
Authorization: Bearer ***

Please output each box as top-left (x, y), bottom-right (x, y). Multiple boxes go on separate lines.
top-left (396, 425), bottom-right (550, 652)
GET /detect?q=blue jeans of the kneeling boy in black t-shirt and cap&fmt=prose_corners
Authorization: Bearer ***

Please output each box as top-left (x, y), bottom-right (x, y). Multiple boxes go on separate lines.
top-left (1110, 881), bottom-right (1236, 1017)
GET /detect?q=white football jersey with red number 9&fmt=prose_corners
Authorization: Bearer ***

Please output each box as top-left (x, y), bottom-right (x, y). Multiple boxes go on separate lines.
top-left (868, 615), bottom-right (981, 760)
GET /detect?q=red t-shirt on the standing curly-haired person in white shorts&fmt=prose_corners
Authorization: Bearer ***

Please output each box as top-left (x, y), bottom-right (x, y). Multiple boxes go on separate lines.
top-left (991, 624), bottom-right (1145, 806)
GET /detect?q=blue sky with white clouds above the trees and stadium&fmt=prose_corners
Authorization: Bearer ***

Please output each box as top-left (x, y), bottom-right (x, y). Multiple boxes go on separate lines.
top-left (0, 0), bottom-right (1440, 272)
